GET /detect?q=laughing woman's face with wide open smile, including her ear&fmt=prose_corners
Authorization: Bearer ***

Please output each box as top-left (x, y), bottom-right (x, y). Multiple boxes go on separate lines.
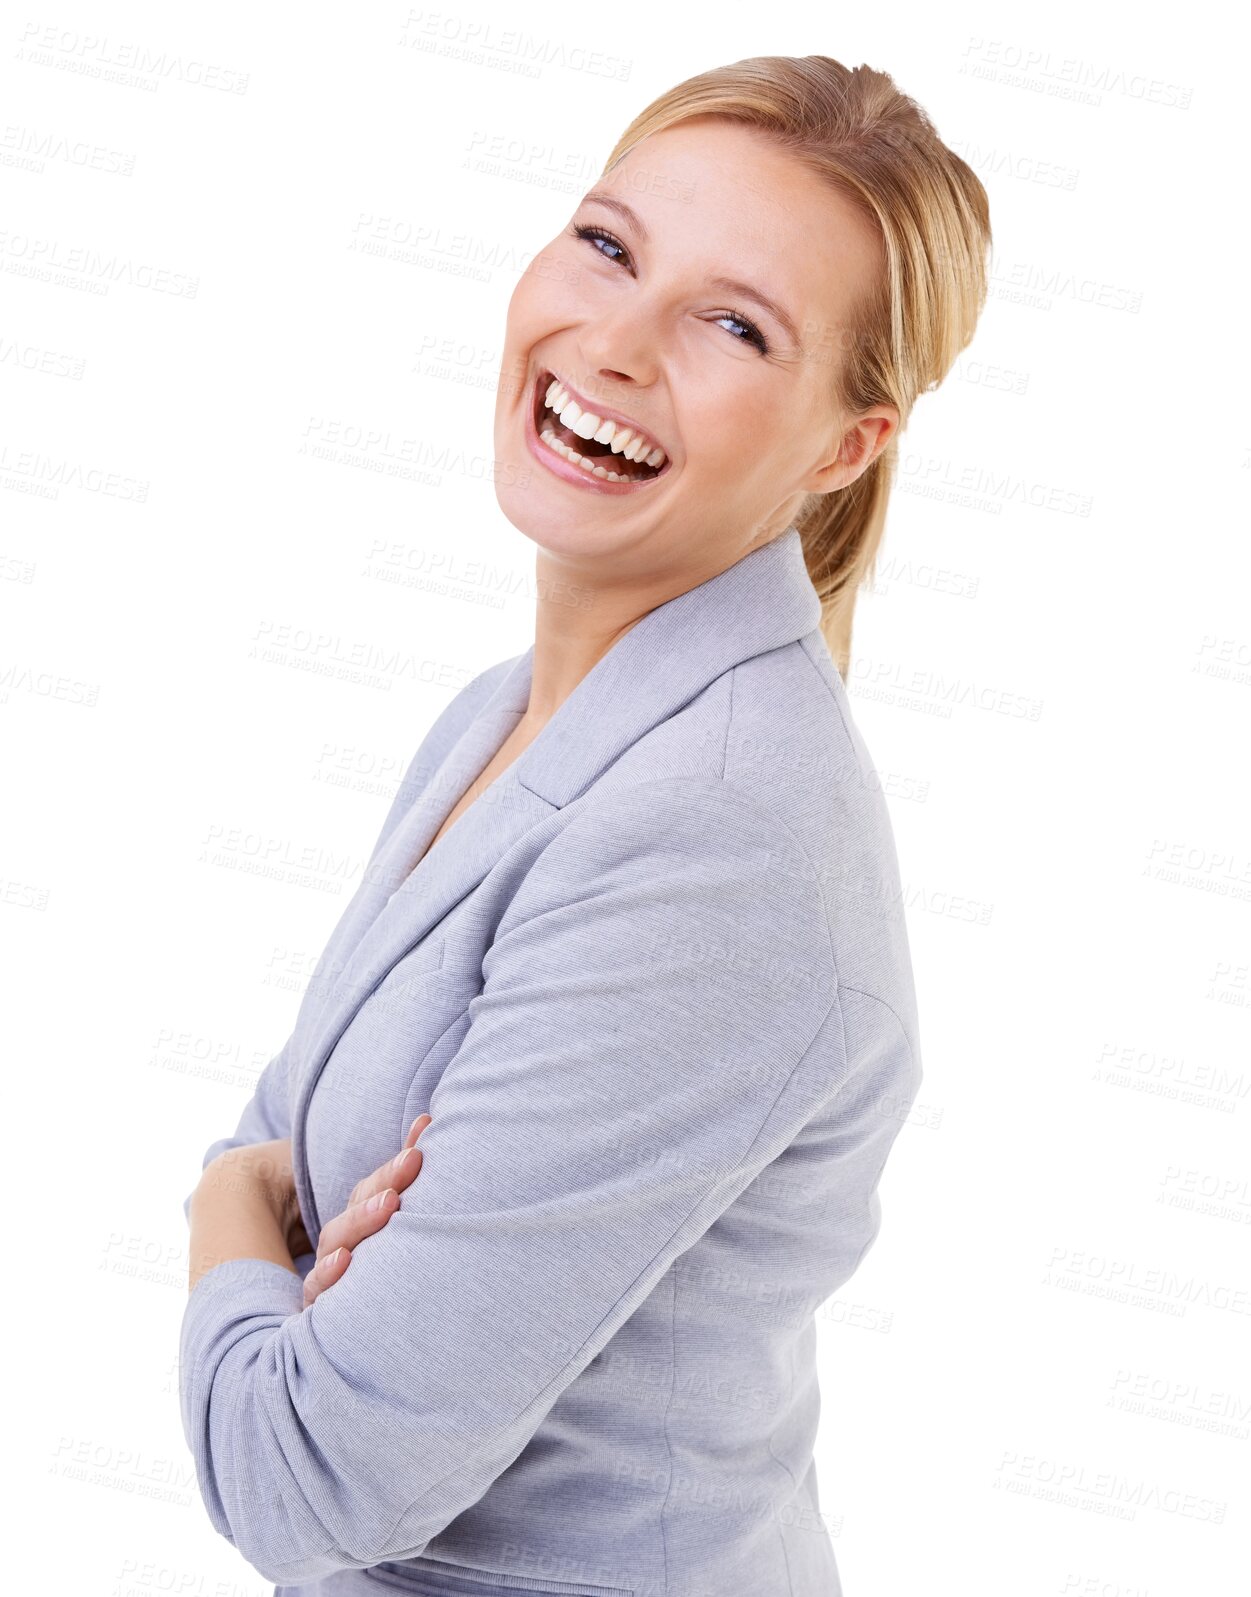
top-left (495, 117), bottom-right (898, 580)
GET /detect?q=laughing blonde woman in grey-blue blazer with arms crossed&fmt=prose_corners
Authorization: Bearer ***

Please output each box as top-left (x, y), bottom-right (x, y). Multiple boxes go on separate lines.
top-left (181, 56), bottom-right (989, 1597)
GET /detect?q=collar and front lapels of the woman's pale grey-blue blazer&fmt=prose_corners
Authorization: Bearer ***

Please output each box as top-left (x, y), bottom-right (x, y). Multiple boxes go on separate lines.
top-left (292, 527), bottom-right (821, 1246)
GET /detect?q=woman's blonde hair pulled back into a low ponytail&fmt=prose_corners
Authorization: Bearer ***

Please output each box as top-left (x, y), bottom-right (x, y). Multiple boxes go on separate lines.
top-left (604, 56), bottom-right (992, 677)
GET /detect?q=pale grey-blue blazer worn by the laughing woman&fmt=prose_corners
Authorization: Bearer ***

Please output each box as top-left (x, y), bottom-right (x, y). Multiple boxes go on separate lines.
top-left (181, 527), bottom-right (920, 1597)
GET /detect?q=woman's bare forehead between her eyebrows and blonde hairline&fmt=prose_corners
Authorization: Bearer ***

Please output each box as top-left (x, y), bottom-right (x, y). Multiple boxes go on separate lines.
top-left (593, 117), bottom-right (880, 335)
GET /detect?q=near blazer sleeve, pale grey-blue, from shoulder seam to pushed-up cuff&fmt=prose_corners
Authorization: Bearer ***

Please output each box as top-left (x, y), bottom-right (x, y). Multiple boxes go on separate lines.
top-left (181, 778), bottom-right (847, 1584)
